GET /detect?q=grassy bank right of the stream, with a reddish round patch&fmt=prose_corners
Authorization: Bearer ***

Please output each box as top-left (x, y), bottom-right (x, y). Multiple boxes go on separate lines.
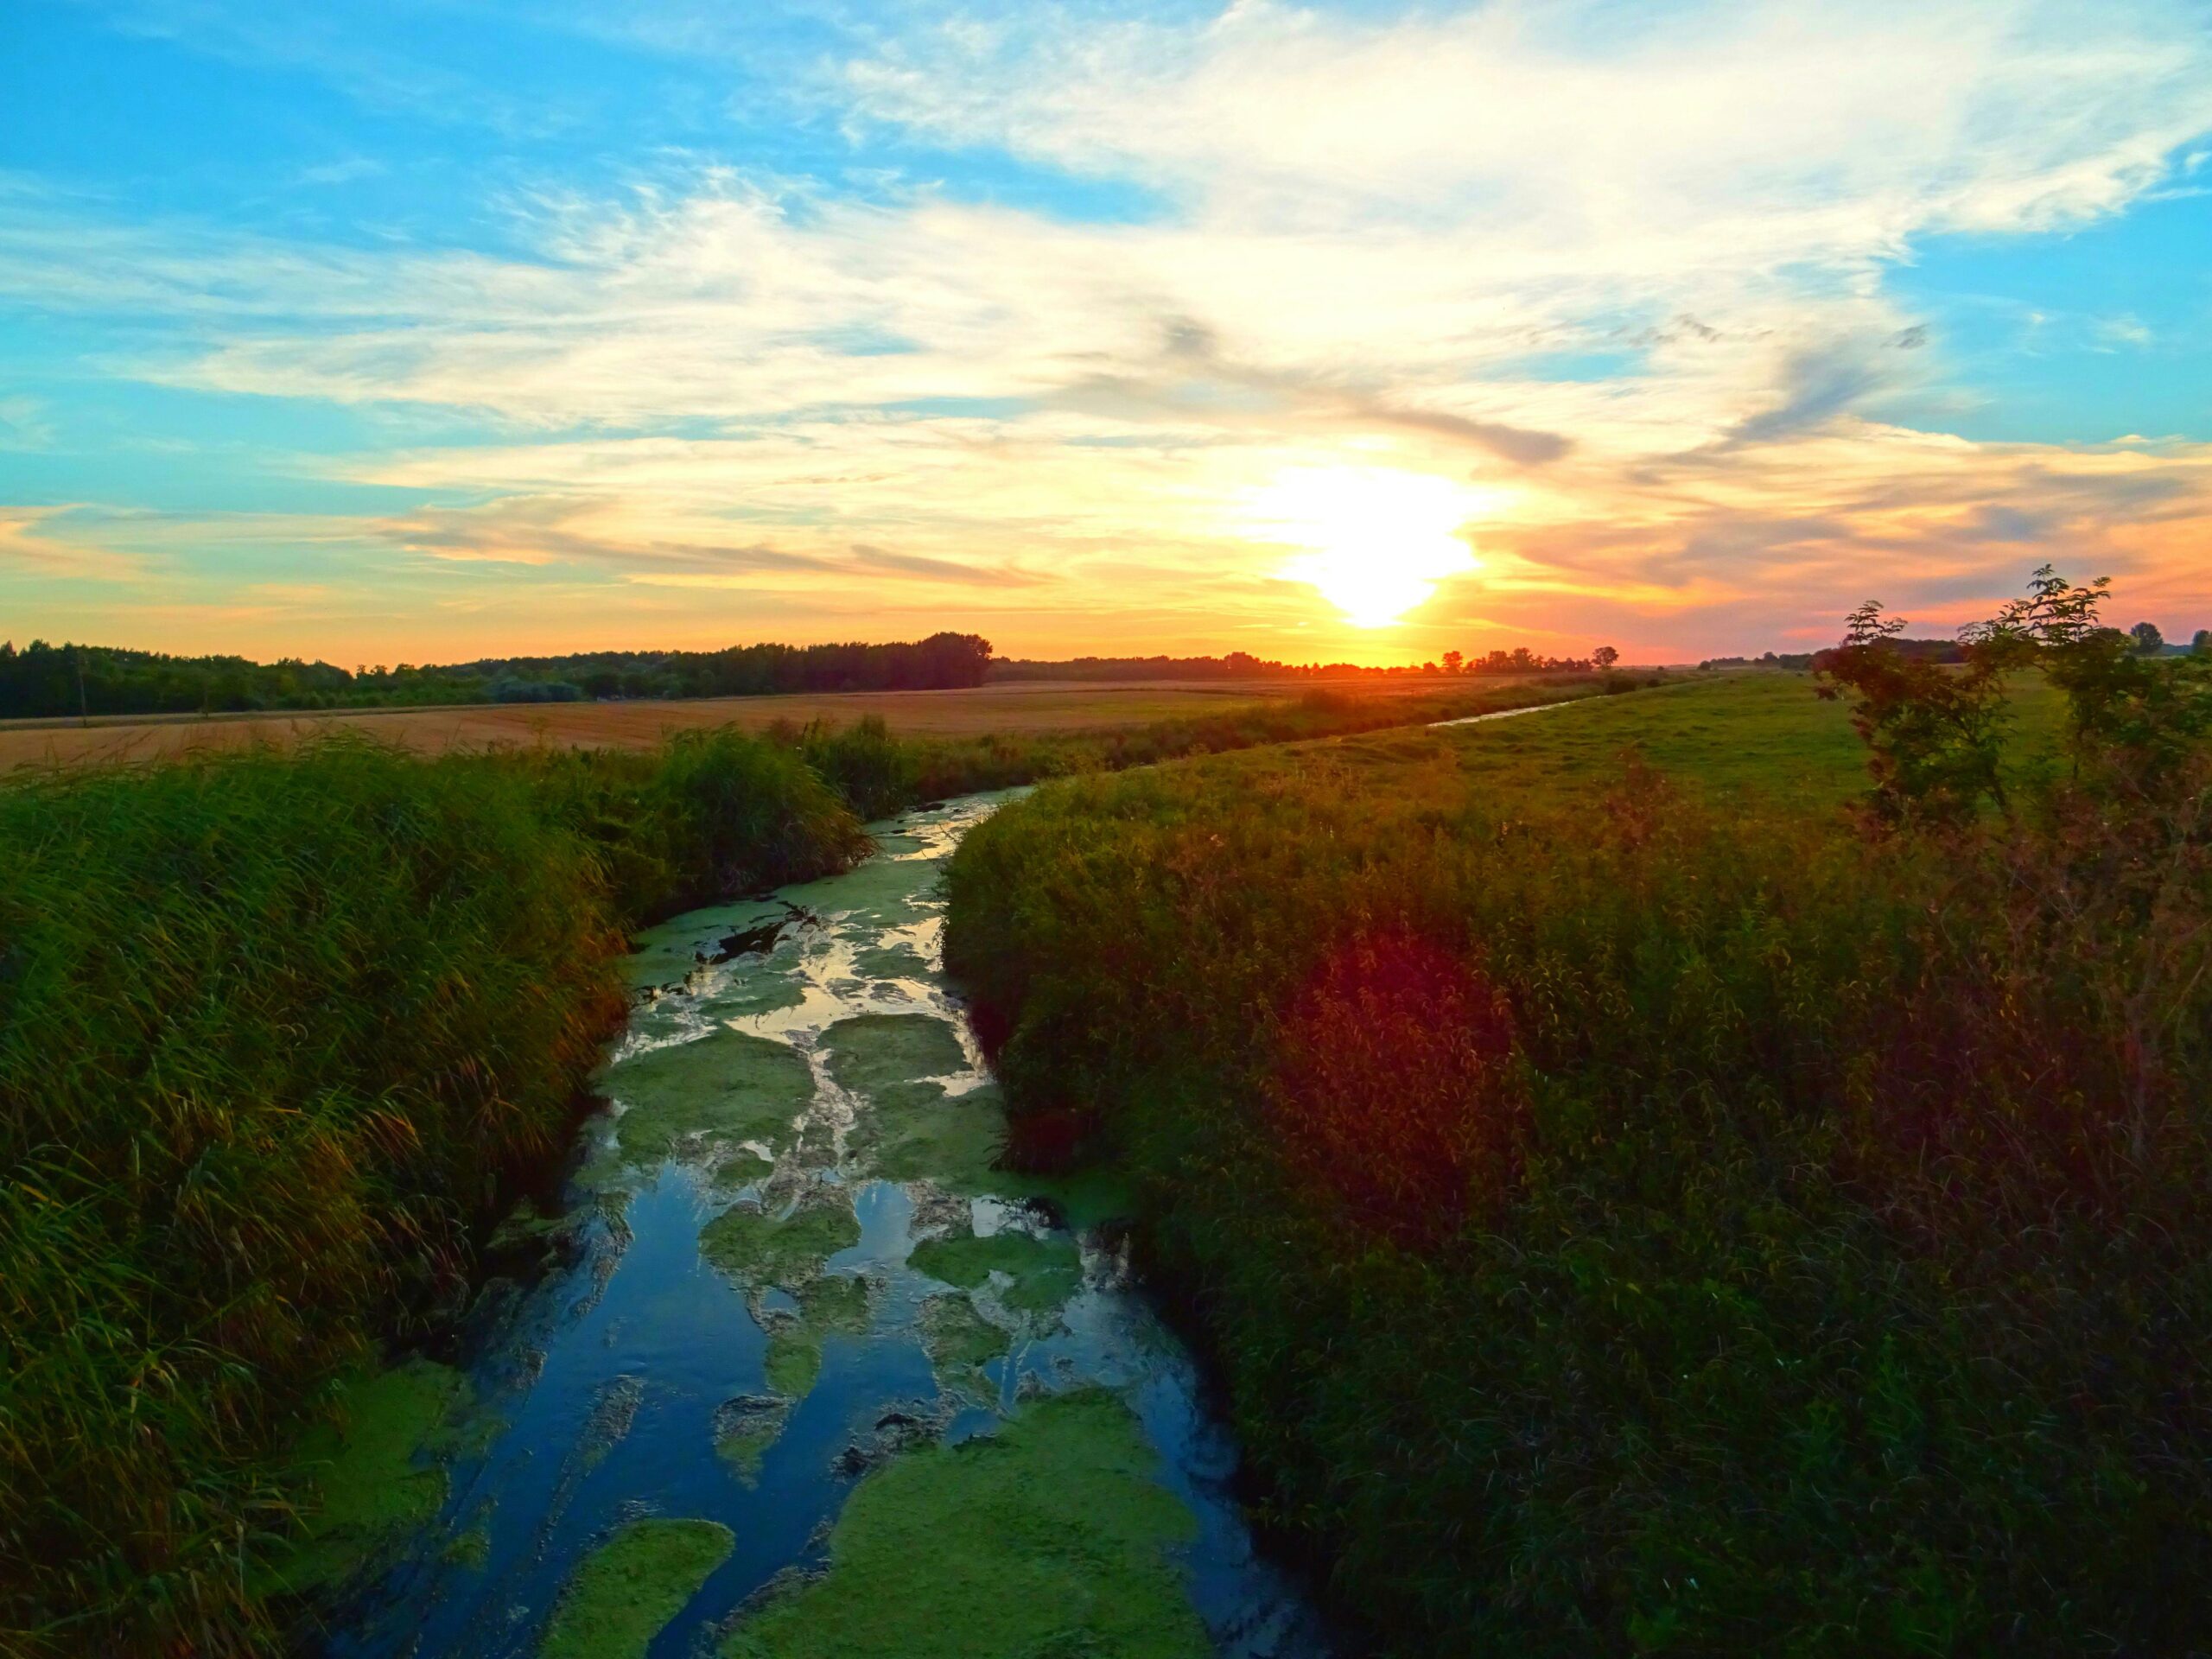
top-left (947, 677), bottom-right (2212, 1655)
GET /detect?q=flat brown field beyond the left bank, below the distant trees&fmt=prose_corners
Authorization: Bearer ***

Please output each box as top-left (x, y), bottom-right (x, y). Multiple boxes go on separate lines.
top-left (0, 677), bottom-right (1516, 770)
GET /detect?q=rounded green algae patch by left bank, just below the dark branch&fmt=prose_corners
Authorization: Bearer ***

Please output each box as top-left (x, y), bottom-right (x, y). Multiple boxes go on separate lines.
top-left (600, 1028), bottom-right (814, 1164)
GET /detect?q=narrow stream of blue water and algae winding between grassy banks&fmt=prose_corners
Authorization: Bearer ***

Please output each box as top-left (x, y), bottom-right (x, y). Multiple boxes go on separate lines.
top-left (327, 791), bottom-right (1325, 1659)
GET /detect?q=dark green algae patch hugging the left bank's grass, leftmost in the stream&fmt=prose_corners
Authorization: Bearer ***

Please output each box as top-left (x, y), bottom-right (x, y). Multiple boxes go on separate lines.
top-left (265, 1360), bottom-right (467, 1595)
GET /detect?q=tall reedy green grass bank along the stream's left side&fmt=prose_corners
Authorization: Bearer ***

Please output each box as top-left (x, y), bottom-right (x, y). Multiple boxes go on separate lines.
top-left (0, 681), bottom-right (1595, 1655)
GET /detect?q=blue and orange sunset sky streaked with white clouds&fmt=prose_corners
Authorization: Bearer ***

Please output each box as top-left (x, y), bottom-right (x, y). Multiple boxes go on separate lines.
top-left (0, 0), bottom-right (2212, 666)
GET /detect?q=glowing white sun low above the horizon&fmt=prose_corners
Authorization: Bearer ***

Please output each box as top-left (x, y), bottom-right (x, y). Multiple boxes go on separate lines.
top-left (1249, 467), bottom-right (1493, 628)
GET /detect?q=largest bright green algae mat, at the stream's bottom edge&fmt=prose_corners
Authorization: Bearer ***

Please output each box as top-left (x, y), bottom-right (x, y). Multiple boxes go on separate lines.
top-left (721, 1391), bottom-right (1212, 1659)
